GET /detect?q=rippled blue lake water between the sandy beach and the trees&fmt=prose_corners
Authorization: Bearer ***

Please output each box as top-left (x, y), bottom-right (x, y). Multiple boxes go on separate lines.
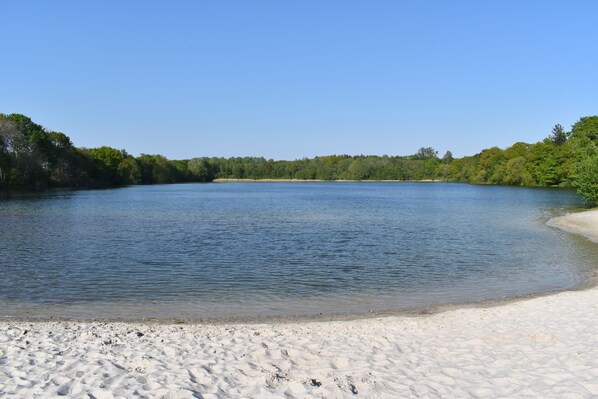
top-left (0, 183), bottom-right (598, 319)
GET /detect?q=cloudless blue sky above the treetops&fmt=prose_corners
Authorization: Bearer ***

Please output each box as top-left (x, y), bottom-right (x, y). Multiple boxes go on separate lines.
top-left (0, 0), bottom-right (598, 159)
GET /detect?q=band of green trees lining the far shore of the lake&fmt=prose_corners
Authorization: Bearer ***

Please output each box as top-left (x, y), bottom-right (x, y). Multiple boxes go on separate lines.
top-left (0, 114), bottom-right (598, 206)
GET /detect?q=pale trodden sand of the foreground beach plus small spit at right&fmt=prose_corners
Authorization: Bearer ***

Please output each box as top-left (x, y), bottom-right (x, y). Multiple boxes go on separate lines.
top-left (0, 211), bottom-right (598, 398)
